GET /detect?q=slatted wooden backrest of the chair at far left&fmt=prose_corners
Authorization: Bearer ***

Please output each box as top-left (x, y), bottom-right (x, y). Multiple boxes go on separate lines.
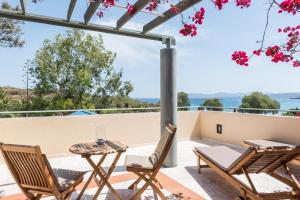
top-left (0, 144), bottom-right (58, 192)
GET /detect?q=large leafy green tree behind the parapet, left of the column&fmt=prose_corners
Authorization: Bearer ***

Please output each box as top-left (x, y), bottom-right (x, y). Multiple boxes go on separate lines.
top-left (30, 29), bottom-right (133, 109)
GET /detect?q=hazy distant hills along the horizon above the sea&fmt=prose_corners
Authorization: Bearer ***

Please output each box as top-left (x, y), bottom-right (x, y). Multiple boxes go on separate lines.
top-left (189, 92), bottom-right (300, 99)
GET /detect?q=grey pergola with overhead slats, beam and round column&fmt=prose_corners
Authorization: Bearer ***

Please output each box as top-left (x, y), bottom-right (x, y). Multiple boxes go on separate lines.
top-left (0, 0), bottom-right (201, 167)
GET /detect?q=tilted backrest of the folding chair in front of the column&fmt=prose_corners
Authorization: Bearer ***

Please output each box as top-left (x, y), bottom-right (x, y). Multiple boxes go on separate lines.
top-left (149, 124), bottom-right (177, 168)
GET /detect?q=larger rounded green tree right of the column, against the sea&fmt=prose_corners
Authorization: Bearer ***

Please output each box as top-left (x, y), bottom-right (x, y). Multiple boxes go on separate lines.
top-left (239, 92), bottom-right (280, 114)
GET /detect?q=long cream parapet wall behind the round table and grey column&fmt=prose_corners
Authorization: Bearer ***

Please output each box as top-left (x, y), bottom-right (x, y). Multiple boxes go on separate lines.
top-left (0, 112), bottom-right (200, 159)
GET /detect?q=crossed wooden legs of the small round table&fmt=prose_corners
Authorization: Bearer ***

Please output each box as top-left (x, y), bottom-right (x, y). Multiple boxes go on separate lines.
top-left (86, 152), bottom-right (122, 200)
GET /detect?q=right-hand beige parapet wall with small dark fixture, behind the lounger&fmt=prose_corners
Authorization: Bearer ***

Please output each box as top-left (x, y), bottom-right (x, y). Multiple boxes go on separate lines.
top-left (199, 111), bottom-right (300, 145)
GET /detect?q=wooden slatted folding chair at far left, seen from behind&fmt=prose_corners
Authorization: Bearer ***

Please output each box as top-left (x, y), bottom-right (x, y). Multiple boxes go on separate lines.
top-left (0, 144), bottom-right (85, 200)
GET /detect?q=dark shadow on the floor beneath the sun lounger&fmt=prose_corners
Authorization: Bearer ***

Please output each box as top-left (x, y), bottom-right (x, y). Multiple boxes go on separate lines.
top-left (185, 166), bottom-right (239, 200)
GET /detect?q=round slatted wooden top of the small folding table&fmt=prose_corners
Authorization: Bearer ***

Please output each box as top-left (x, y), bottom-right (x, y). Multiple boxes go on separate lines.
top-left (69, 140), bottom-right (128, 156)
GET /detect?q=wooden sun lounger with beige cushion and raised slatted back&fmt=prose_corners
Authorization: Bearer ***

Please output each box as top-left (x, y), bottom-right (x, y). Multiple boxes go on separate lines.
top-left (193, 145), bottom-right (300, 200)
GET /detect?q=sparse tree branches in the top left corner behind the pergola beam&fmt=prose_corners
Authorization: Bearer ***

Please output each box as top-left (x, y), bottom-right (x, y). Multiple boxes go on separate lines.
top-left (0, 1), bottom-right (24, 48)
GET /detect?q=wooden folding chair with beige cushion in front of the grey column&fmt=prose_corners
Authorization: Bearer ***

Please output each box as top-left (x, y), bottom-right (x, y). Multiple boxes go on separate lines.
top-left (125, 124), bottom-right (176, 200)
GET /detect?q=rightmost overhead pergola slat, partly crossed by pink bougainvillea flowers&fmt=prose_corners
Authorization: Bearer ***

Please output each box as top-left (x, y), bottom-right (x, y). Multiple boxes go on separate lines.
top-left (143, 0), bottom-right (202, 33)
